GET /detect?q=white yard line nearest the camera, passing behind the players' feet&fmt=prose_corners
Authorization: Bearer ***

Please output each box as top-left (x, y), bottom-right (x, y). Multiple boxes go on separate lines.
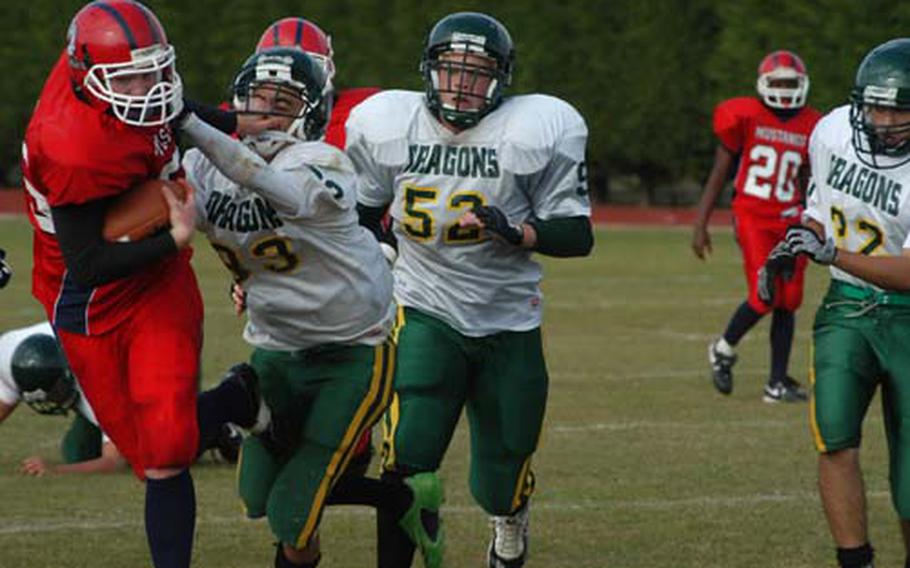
top-left (0, 491), bottom-right (890, 536)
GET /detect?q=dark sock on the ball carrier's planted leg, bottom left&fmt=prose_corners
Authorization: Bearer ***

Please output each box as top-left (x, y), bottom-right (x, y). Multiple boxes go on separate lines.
top-left (145, 470), bottom-right (196, 568)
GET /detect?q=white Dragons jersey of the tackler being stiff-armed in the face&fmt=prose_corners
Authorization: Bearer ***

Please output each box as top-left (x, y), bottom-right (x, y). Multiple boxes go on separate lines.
top-left (183, 139), bottom-right (395, 351)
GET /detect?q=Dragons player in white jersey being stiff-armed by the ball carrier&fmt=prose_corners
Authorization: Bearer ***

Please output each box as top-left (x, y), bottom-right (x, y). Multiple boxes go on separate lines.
top-left (179, 47), bottom-right (446, 568)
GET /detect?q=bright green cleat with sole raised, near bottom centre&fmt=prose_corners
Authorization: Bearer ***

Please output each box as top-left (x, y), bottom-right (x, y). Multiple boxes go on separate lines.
top-left (398, 472), bottom-right (445, 568)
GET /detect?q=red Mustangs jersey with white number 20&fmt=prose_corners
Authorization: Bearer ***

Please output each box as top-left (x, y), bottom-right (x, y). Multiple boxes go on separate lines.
top-left (714, 97), bottom-right (822, 220)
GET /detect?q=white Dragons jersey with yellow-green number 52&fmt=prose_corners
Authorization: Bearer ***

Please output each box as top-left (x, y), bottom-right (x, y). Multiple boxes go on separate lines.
top-left (346, 91), bottom-right (590, 337)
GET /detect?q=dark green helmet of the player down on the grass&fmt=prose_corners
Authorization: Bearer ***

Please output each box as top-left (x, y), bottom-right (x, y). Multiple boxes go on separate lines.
top-left (11, 333), bottom-right (79, 414)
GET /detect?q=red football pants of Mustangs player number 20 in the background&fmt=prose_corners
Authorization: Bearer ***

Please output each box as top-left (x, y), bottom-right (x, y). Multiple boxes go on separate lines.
top-left (736, 215), bottom-right (806, 314)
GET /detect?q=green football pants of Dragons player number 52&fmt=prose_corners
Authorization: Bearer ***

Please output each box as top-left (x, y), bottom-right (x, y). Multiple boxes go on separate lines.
top-left (383, 308), bottom-right (548, 515)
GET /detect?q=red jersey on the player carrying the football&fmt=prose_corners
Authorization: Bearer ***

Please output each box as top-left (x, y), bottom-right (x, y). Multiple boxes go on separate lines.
top-left (22, 53), bottom-right (194, 335)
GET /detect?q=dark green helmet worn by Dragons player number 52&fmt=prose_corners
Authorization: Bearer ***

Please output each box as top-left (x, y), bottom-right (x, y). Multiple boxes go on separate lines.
top-left (420, 12), bottom-right (515, 129)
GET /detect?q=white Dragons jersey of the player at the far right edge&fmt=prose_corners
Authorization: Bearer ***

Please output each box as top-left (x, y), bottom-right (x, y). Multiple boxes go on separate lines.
top-left (803, 105), bottom-right (910, 288)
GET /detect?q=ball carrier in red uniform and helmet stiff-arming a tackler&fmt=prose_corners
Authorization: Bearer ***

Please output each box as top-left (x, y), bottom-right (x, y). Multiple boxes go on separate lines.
top-left (22, 0), bottom-right (268, 568)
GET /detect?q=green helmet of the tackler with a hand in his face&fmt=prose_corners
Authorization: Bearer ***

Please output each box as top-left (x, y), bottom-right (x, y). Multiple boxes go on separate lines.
top-left (233, 47), bottom-right (331, 144)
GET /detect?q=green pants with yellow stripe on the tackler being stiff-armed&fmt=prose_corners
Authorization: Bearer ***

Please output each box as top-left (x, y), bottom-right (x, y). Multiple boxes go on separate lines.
top-left (238, 341), bottom-right (395, 548)
